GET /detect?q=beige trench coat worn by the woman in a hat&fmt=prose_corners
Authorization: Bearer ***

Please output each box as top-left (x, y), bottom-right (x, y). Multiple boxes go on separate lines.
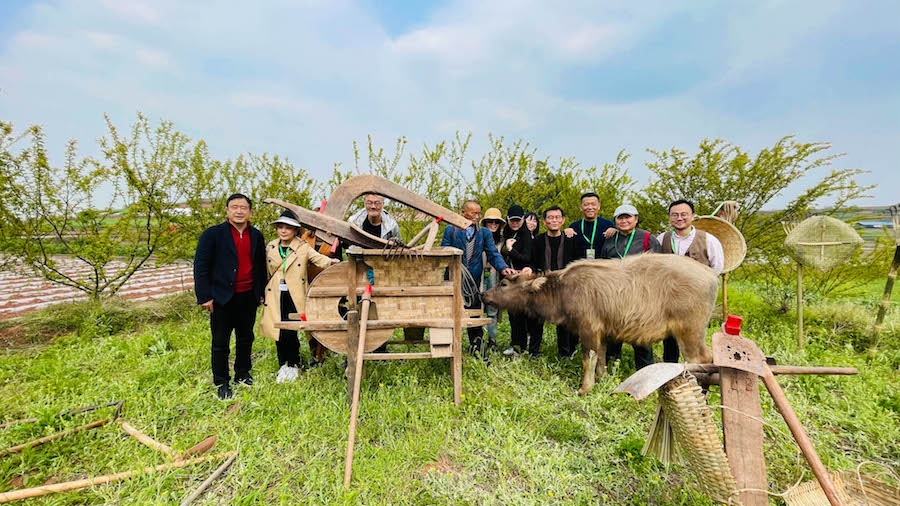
top-left (260, 237), bottom-right (331, 341)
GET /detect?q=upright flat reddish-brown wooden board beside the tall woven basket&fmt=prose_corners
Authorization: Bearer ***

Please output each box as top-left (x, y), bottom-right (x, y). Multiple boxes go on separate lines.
top-left (719, 367), bottom-right (769, 506)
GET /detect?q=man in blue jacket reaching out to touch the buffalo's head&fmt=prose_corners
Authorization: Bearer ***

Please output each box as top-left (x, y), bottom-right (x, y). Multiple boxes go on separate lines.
top-left (441, 200), bottom-right (516, 353)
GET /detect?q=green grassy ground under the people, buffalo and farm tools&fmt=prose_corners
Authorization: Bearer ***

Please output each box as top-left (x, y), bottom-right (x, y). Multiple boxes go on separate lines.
top-left (0, 282), bottom-right (900, 505)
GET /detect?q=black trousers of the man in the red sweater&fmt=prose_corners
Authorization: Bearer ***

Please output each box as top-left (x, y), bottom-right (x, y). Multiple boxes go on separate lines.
top-left (209, 290), bottom-right (257, 386)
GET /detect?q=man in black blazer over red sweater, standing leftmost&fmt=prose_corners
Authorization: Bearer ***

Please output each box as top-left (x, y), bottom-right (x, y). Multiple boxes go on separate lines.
top-left (194, 193), bottom-right (266, 400)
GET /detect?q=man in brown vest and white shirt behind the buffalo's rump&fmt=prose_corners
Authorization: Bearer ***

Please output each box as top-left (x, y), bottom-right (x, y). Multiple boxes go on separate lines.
top-left (658, 199), bottom-right (725, 362)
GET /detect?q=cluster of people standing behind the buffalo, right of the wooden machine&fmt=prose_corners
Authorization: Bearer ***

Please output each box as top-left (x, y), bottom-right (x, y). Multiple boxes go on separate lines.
top-left (441, 192), bottom-right (724, 369)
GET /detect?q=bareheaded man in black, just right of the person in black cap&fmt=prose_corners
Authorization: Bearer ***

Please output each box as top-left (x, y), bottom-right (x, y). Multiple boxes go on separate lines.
top-left (525, 206), bottom-right (578, 358)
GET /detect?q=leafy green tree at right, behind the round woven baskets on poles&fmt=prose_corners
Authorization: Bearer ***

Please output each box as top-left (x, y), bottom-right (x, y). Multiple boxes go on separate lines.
top-left (637, 136), bottom-right (882, 293)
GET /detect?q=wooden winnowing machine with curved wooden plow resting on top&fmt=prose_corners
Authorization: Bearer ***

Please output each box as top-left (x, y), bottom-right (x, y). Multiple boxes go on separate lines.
top-left (265, 175), bottom-right (491, 487)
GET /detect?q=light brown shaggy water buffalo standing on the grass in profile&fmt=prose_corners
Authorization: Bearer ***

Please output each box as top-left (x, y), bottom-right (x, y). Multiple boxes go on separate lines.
top-left (483, 253), bottom-right (718, 395)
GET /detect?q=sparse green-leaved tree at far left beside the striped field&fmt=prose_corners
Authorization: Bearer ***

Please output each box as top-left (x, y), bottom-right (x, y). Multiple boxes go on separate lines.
top-left (3, 114), bottom-right (200, 299)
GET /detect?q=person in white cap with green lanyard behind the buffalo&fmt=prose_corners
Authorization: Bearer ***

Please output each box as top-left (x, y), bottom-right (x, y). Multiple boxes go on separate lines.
top-left (600, 204), bottom-right (660, 370)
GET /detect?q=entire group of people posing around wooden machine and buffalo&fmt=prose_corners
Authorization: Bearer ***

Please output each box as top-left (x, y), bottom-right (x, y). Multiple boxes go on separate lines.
top-left (194, 193), bottom-right (724, 400)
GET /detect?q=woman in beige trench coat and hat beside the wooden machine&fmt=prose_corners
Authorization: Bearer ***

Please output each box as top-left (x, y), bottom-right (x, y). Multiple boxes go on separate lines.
top-left (260, 211), bottom-right (339, 383)
